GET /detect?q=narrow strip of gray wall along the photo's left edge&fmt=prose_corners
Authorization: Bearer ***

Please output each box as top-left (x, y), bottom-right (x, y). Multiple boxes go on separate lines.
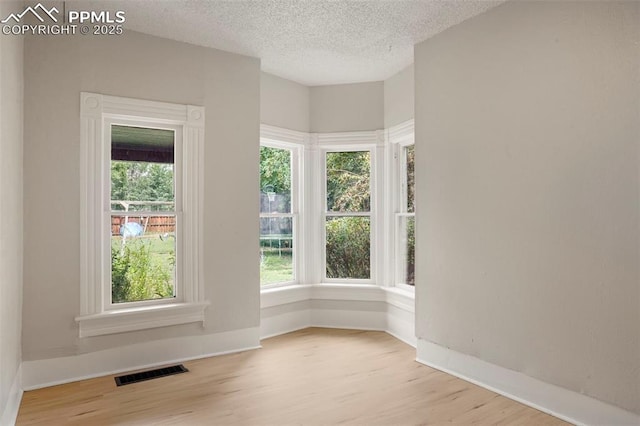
top-left (0, 2), bottom-right (23, 423)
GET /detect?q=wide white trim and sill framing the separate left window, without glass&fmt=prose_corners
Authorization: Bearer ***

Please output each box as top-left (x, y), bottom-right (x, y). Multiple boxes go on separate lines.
top-left (76, 92), bottom-right (209, 337)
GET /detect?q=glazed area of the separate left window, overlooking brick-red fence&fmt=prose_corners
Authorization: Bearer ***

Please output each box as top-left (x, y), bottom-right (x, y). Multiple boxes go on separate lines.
top-left (105, 122), bottom-right (181, 309)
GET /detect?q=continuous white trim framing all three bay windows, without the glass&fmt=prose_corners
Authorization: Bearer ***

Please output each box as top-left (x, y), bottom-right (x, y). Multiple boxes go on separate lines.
top-left (260, 125), bottom-right (414, 292)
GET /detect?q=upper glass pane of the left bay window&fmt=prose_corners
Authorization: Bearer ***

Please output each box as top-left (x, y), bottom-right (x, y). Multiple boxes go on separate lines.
top-left (260, 146), bottom-right (291, 213)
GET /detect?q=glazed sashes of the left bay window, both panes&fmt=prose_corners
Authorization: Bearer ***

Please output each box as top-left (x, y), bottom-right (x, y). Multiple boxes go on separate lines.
top-left (260, 143), bottom-right (297, 287)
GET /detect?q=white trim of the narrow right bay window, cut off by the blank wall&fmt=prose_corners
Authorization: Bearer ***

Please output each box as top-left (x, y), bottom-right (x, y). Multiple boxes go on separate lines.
top-left (387, 120), bottom-right (415, 292)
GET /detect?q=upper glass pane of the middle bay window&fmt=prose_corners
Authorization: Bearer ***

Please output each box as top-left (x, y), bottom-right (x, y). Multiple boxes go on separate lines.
top-left (326, 151), bottom-right (371, 212)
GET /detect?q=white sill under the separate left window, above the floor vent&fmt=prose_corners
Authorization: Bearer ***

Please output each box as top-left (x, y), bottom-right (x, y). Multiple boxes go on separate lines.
top-left (76, 302), bottom-right (209, 337)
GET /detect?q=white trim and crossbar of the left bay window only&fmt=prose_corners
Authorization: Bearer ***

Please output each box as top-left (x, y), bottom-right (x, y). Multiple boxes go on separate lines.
top-left (260, 125), bottom-right (308, 290)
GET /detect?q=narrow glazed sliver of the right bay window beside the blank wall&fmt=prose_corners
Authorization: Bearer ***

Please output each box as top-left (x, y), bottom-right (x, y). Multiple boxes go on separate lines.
top-left (396, 145), bottom-right (416, 286)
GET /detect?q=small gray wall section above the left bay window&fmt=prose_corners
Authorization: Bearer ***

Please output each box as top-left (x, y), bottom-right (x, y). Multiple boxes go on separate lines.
top-left (260, 72), bottom-right (310, 132)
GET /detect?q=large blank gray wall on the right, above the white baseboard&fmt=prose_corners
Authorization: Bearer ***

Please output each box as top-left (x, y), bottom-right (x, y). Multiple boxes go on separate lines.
top-left (415, 2), bottom-right (640, 413)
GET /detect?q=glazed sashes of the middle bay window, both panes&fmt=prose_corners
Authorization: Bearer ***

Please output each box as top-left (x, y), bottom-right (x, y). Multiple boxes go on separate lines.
top-left (323, 150), bottom-right (372, 281)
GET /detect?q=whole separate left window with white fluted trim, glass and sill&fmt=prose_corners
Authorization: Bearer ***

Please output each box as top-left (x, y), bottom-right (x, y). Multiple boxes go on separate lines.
top-left (76, 93), bottom-right (207, 337)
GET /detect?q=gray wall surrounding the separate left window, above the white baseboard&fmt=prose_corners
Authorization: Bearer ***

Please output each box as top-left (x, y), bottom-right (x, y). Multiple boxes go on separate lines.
top-left (23, 31), bottom-right (260, 360)
